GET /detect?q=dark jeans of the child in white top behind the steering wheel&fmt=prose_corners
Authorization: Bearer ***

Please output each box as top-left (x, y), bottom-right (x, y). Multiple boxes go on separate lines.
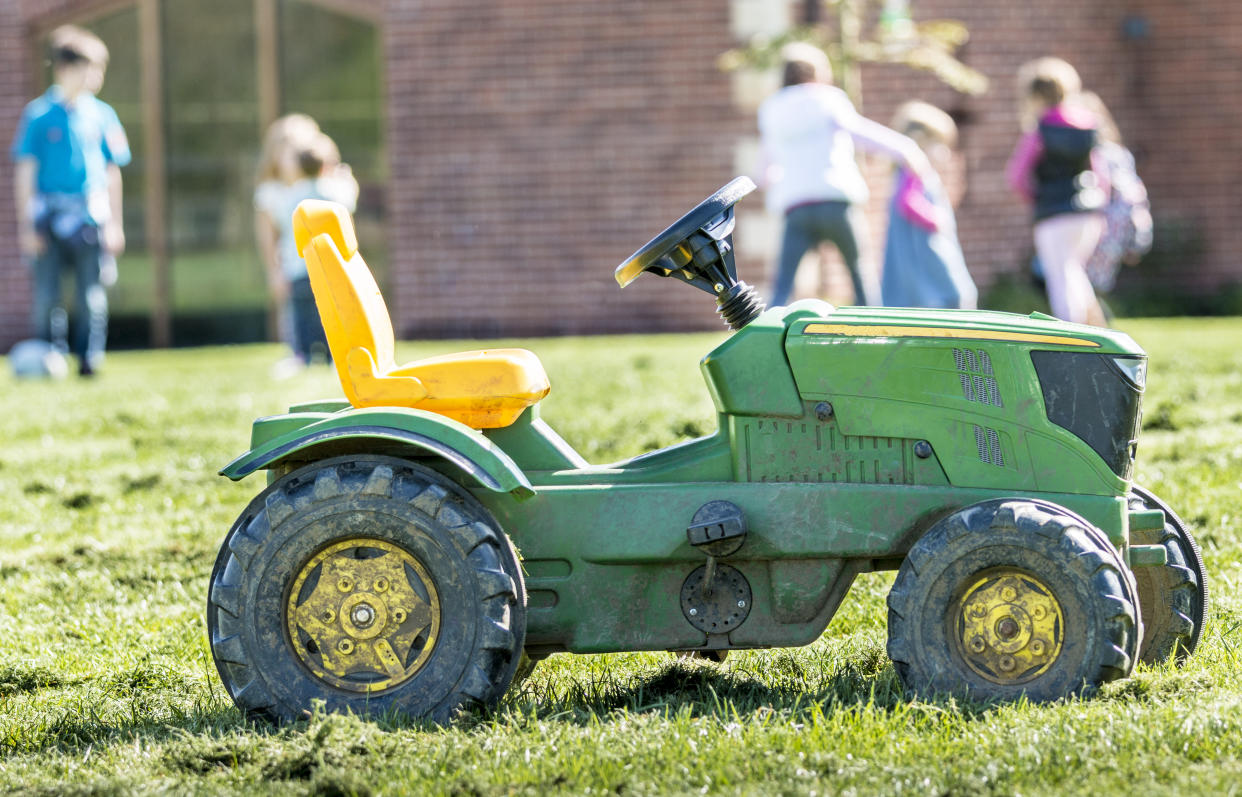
top-left (771, 200), bottom-right (877, 307)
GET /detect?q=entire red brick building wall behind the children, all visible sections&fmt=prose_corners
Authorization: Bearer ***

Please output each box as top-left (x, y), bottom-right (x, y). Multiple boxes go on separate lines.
top-left (0, 0), bottom-right (1242, 350)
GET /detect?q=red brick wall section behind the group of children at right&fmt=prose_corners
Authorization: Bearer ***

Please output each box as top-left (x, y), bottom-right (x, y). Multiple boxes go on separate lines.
top-left (863, 0), bottom-right (1242, 300)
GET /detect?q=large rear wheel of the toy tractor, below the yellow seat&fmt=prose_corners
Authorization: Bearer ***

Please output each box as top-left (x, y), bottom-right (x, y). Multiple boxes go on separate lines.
top-left (207, 457), bottom-right (525, 723)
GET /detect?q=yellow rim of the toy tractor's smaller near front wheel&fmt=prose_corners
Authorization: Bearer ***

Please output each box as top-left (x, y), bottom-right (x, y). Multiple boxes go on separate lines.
top-left (951, 570), bottom-right (1066, 685)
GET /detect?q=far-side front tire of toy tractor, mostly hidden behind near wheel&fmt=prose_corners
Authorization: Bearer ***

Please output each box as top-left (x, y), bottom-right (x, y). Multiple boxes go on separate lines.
top-left (1130, 484), bottom-right (1208, 665)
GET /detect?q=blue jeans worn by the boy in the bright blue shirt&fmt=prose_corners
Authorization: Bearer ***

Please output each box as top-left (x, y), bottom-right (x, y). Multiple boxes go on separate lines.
top-left (31, 226), bottom-right (108, 367)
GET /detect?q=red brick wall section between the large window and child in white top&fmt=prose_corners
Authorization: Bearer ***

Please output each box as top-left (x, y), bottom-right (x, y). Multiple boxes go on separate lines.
top-left (385, 0), bottom-right (751, 335)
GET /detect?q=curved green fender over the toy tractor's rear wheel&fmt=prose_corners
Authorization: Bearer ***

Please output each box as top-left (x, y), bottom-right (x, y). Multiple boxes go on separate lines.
top-left (220, 407), bottom-right (534, 498)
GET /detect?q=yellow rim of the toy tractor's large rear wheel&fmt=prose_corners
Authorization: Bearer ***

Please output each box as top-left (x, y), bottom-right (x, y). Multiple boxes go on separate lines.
top-left (284, 538), bottom-right (440, 694)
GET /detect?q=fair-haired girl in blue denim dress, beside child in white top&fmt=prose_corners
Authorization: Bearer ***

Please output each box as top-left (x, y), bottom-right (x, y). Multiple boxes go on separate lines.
top-left (881, 102), bottom-right (979, 309)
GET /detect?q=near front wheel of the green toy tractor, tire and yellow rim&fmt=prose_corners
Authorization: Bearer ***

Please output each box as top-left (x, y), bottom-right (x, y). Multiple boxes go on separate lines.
top-left (888, 500), bottom-right (1139, 701)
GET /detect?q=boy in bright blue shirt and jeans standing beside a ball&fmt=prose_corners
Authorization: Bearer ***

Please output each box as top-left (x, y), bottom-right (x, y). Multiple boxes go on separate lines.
top-left (12, 26), bottom-right (130, 376)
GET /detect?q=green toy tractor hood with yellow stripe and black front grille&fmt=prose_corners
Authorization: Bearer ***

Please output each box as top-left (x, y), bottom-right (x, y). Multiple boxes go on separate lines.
top-left (785, 305), bottom-right (1146, 493)
